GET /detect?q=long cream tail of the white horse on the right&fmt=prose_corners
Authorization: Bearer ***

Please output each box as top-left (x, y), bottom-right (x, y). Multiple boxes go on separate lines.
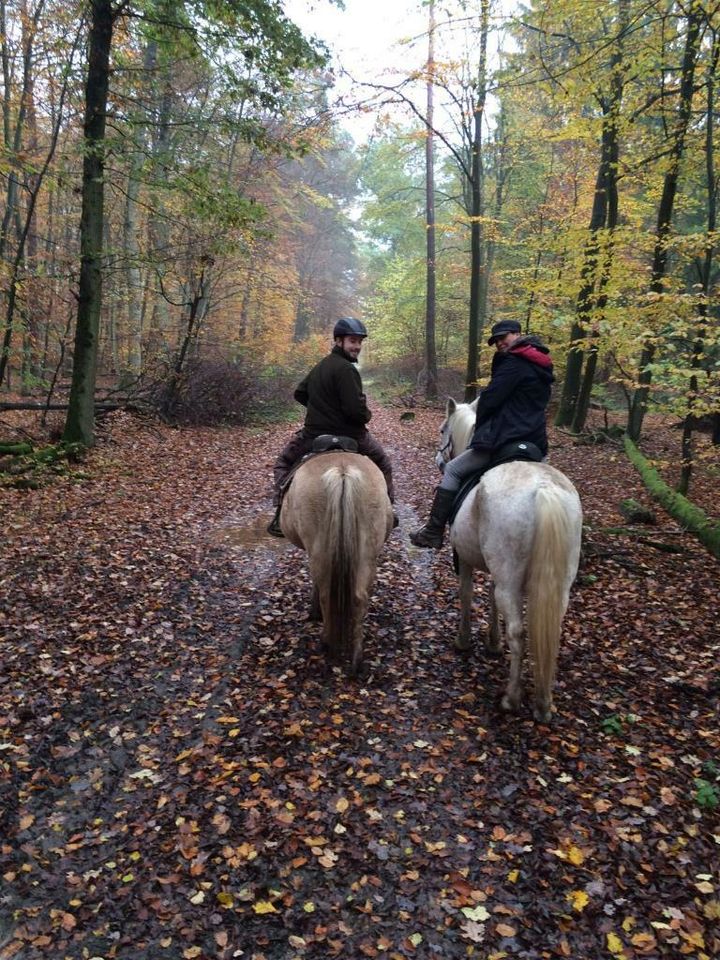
top-left (527, 484), bottom-right (574, 721)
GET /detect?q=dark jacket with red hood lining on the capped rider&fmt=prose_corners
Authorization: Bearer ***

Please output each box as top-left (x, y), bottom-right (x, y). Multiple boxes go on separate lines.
top-left (470, 336), bottom-right (555, 456)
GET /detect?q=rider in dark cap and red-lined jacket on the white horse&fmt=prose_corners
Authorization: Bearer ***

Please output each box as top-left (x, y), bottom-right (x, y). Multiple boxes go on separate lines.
top-left (410, 320), bottom-right (555, 550)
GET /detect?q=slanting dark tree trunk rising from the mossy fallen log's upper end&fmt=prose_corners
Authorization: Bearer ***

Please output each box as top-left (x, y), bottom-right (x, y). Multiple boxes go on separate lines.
top-left (627, 6), bottom-right (701, 443)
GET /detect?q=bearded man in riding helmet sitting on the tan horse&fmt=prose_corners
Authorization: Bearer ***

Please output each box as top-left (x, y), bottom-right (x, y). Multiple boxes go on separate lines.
top-left (267, 317), bottom-right (397, 537)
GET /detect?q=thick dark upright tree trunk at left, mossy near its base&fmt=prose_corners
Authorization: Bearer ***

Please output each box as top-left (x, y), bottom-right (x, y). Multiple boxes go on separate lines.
top-left (63, 0), bottom-right (113, 447)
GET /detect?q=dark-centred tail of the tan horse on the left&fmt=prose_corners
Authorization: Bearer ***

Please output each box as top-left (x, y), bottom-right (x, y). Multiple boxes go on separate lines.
top-left (323, 467), bottom-right (362, 663)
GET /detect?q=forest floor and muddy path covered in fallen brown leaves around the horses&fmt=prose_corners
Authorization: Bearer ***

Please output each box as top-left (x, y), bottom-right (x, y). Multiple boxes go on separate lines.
top-left (0, 408), bottom-right (720, 960)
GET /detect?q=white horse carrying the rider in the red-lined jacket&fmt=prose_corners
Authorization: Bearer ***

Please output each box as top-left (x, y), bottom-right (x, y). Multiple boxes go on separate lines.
top-left (436, 398), bottom-right (582, 723)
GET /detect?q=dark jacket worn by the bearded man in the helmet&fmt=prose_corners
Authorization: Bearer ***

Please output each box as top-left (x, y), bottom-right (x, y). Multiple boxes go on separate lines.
top-left (294, 346), bottom-right (372, 440)
